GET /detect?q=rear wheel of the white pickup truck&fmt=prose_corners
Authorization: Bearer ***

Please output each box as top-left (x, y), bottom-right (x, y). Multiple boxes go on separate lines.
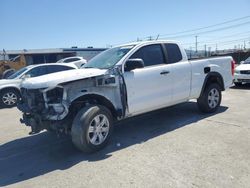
top-left (197, 83), bottom-right (222, 113)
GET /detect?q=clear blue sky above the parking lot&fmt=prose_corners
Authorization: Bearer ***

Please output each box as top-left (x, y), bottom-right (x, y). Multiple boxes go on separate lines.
top-left (0, 0), bottom-right (250, 50)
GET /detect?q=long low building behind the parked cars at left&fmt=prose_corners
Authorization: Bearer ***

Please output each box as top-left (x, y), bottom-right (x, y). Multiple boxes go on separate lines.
top-left (0, 47), bottom-right (106, 65)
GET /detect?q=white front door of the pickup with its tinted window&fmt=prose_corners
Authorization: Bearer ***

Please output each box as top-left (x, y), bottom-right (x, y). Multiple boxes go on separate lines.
top-left (124, 44), bottom-right (173, 115)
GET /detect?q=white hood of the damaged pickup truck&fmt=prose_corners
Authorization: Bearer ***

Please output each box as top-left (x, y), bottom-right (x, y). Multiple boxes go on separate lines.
top-left (21, 68), bottom-right (107, 89)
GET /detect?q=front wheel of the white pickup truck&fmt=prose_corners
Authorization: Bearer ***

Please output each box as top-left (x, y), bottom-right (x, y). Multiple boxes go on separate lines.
top-left (71, 105), bottom-right (113, 153)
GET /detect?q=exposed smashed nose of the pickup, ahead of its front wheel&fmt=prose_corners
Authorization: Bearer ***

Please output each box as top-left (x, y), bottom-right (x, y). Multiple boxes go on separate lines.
top-left (17, 86), bottom-right (68, 134)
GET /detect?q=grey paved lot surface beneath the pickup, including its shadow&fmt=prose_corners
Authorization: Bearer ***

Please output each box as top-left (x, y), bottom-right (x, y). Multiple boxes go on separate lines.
top-left (0, 86), bottom-right (250, 188)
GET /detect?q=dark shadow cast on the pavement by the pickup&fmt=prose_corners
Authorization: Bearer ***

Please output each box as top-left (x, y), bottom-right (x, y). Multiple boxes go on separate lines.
top-left (0, 102), bottom-right (227, 186)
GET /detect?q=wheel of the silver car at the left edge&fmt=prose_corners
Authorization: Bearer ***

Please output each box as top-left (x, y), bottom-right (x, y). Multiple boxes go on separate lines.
top-left (0, 89), bottom-right (21, 108)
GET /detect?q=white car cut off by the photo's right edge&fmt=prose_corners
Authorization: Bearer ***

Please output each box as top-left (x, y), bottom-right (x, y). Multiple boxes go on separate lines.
top-left (234, 57), bottom-right (250, 86)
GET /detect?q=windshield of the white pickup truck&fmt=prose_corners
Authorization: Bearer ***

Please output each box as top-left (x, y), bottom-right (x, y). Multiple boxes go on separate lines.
top-left (82, 46), bottom-right (134, 69)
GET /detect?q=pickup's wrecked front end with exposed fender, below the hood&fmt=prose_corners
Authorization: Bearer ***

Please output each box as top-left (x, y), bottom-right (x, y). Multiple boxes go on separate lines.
top-left (18, 70), bottom-right (127, 134)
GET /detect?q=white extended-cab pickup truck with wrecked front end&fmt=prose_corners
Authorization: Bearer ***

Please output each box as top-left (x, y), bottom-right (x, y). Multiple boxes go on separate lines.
top-left (18, 41), bottom-right (234, 152)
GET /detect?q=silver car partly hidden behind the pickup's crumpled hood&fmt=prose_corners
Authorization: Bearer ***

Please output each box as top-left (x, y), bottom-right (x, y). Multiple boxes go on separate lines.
top-left (0, 63), bottom-right (78, 108)
